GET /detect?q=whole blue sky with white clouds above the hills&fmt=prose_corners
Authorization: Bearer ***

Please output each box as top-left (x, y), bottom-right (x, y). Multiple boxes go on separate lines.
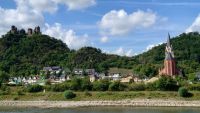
top-left (0, 0), bottom-right (200, 56)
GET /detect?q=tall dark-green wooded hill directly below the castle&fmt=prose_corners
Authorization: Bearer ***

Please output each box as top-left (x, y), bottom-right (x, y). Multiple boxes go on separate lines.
top-left (0, 33), bottom-right (70, 76)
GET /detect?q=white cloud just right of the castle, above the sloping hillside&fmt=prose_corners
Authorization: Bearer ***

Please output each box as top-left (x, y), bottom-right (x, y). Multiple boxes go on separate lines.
top-left (44, 23), bottom-right (91, 49)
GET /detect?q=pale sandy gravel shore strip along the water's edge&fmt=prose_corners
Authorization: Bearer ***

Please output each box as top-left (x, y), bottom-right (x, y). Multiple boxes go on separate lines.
top-left (0, 99), bottom-right (200, 108)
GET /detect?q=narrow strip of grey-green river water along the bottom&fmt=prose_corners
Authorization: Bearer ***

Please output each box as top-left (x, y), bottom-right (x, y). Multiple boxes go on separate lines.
top-left (0, 107), bottom-right (200, 113)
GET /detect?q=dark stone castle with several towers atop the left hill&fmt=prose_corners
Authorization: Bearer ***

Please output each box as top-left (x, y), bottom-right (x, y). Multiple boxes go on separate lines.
top-left (9, 25), bottom-right (41, 36)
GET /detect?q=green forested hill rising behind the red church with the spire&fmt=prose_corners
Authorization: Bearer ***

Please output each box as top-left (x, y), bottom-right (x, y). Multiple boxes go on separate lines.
top-left (134, 32), bottom-right (200, 75)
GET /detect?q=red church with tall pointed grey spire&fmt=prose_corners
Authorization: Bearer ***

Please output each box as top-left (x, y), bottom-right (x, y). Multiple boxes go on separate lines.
top-left (159, 34), bottom-right (181, 76)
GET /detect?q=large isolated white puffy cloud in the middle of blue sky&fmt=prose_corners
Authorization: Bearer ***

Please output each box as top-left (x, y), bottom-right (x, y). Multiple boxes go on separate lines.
top-left (98, 9), bottom-right (157, 35)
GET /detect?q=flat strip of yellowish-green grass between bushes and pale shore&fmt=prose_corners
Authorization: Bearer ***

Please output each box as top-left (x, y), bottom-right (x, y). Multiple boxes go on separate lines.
top-left (0, 91), bottom-right (200, 101)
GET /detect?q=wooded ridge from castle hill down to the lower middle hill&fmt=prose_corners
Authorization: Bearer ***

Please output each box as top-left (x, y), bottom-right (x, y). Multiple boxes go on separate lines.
top-left (0, 32), bottom-right (132, 76)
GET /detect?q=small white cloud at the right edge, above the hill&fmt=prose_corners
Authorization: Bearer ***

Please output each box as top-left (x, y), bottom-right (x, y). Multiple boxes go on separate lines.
top-left (185, 15), bottom-right (200, 33)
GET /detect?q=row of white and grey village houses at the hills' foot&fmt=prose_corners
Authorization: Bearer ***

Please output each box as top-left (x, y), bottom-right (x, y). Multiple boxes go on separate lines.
top-left (9, 66), bottom-right (145, 85)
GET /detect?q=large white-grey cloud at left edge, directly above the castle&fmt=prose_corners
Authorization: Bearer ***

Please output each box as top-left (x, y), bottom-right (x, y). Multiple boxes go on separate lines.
top-left (0, 0), bottom-right (44, 35)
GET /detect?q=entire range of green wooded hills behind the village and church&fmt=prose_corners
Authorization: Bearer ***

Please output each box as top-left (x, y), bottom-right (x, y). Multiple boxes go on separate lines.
top-left (0, 32), bottom-right (200, 77)
